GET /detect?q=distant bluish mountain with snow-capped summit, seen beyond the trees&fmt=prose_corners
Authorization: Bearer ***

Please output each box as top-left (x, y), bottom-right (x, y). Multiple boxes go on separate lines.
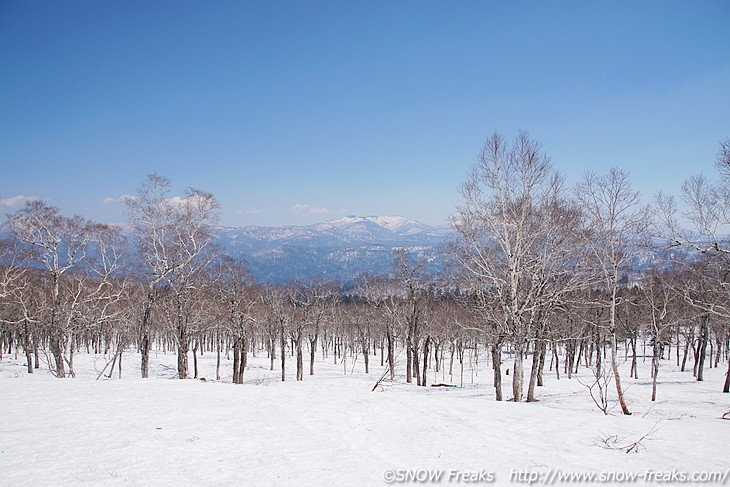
top-left (213, 216), bottom-right (449, 283)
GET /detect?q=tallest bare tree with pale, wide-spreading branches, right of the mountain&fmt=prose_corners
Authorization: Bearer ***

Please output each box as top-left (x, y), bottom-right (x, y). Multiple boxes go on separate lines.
top-left (452, 132), bottom-right (566, 402)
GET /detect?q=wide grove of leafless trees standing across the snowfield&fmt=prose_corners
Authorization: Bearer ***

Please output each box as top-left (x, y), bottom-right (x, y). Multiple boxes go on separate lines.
top-left (0, 136), bottom-right (730, 414)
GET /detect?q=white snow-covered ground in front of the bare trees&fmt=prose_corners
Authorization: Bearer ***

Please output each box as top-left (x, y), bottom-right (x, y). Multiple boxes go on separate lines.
top-left (0, 352), bottom-right (730, 486)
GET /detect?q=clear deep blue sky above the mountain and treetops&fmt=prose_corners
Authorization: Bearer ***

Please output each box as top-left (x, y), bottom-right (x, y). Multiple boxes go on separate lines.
top-left (0, 0), bottom-right (730, 225)
